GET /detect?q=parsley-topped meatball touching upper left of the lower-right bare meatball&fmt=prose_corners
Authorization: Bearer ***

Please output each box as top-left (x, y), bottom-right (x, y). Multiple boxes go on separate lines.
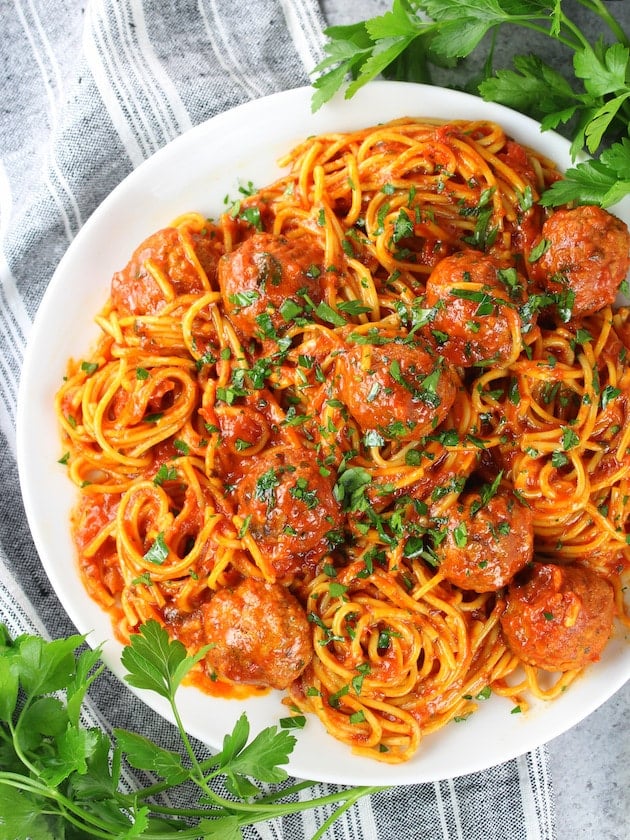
top-left (436, 489), bottom-right (534, 592)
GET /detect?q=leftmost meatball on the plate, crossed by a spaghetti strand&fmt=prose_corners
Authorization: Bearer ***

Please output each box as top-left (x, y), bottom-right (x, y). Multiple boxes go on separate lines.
top-left (111, 228), bottom-right (218, 315)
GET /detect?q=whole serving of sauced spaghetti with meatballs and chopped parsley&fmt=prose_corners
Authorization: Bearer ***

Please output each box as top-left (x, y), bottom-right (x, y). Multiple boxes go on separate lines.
top-left (57, 119), bottom-right (630, 762)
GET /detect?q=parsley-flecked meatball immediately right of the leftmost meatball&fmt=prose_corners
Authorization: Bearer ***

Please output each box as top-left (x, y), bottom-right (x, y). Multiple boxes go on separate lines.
top-left (218, 233), bottom-right (324, 340)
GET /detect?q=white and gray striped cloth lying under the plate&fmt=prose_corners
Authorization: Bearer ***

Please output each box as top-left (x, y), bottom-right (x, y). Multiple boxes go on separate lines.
top-left (0, 0), bottom-right (555, 840)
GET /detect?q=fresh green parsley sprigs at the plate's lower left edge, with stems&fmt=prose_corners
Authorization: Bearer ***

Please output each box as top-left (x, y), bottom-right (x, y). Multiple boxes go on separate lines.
top-left (0, 621), bottom-right (381, 840)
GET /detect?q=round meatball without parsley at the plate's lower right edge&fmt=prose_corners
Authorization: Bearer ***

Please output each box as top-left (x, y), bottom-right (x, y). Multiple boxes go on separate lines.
top-left (501, 563), bottom-right (615, 671)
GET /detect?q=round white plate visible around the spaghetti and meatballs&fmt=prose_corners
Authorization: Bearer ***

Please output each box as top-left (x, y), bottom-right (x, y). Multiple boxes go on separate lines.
top-left (18, 82), bottom-right (630, 785)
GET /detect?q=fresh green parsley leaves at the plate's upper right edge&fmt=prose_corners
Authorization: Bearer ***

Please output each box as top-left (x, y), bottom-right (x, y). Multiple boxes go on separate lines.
top-left (312, 0), bottom-right (630, 207)
